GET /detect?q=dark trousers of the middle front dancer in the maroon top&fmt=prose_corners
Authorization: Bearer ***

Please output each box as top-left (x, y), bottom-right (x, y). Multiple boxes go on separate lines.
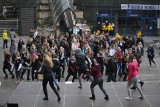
top-left (90, 77), bottom-right (107, 96)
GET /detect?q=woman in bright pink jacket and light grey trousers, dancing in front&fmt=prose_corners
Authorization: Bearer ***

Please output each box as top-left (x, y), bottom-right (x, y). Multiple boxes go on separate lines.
top-left (125, 54), bottom-right (144, 100)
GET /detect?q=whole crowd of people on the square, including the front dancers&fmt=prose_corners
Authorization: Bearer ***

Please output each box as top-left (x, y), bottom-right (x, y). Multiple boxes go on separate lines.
top-left (3, 23), bottom-right (156, 101)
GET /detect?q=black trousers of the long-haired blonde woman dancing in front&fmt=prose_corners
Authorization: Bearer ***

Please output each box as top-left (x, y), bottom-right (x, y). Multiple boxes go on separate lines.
top-left (42, 76), bottom-right (60, 98)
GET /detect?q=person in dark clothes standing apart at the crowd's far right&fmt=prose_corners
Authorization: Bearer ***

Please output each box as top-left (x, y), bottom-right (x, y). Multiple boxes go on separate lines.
top-left (147, 44), bottom-right (156, 66)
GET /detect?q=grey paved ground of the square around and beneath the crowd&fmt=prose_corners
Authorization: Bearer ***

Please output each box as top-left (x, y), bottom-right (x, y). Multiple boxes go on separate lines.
top-left (0, 36), bottom-right (160, 107)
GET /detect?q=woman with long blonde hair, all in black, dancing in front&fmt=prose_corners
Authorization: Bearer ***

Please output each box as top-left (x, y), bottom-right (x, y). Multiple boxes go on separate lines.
top-left (40, 54), bottom-right (61, 101)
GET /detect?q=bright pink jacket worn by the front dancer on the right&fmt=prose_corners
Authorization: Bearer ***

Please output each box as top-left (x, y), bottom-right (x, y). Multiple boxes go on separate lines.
top-left (128, 61), bottom-right (138, 80)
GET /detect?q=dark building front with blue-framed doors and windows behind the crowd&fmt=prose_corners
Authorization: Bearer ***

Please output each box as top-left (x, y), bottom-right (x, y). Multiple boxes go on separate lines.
top-left (74, 0), bottom-right (160, 36)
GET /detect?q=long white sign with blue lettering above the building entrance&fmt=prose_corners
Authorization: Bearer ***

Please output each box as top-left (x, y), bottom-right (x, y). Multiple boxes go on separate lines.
top-left (121, 4), bottom-right (160, 10)
